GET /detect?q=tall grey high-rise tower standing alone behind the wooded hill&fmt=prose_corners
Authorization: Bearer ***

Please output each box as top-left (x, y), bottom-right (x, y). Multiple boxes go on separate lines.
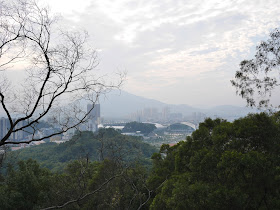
top-left (87, 104), bottom-right (100, 132)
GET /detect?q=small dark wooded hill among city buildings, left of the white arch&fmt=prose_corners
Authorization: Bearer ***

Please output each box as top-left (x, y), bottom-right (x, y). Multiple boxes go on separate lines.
top-left (122, 122), bottom-right (156, 135)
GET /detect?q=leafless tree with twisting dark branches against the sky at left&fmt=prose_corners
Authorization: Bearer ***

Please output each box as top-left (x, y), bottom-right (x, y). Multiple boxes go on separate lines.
top-left (0, 0), bottom-right (125, 146)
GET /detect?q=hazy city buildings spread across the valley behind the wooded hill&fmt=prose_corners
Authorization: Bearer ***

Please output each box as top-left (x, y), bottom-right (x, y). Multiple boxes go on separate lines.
top-left (0, 103), bottom-right (203, 150)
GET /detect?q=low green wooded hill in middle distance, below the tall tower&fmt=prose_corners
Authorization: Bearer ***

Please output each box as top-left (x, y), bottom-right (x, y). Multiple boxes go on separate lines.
top-left (6, 128), bottom-right (157, 171)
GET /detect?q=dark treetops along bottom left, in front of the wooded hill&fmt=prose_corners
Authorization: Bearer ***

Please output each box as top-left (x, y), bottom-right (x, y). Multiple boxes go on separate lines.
top-left (0, 159), bottom-right (151, 210)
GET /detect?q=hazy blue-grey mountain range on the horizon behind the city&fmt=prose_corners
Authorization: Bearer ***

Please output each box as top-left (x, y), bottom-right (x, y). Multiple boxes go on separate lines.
top-left (99, 90), bottom-right (257, 120)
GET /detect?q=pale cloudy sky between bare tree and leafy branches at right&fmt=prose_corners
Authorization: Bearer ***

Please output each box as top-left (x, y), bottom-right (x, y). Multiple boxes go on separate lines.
top-left (41, 0), bottom-right (280, 106)
